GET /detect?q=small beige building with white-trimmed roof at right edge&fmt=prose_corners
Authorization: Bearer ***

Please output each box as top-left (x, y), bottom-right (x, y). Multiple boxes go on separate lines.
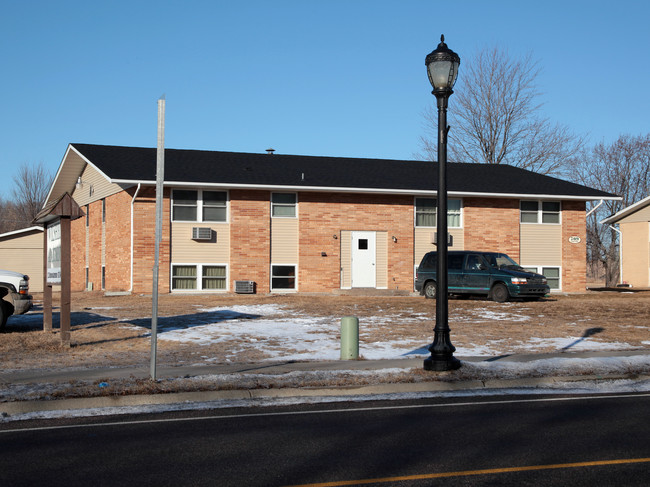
top-left (601, 196), bottom-right (650, 288)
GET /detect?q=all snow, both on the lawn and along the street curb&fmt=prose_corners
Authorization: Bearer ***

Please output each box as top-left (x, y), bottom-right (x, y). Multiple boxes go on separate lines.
top-left (0, 304), bottom-right (650, 423)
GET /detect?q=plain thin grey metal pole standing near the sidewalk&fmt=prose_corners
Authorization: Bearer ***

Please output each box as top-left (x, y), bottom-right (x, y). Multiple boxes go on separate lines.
top-left (151, 95), bottom-right (165, 380)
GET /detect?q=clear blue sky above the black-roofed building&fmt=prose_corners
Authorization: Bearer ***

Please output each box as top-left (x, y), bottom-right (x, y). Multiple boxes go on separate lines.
top-left (0, 0), bottom-right (650, 198)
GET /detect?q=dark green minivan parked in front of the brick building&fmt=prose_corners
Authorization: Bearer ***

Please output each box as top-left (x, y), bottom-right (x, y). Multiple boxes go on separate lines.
top-left (415, 250), bottom-right (551, 303)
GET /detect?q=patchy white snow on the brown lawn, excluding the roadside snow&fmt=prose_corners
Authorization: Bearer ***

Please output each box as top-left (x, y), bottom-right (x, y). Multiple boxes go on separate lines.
top-left (125, 304), bottom-right (631, 361)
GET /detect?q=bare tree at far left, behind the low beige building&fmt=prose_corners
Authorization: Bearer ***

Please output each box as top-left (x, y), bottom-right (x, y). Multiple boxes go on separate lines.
top-left (12, 162), bottom-right (52, 229)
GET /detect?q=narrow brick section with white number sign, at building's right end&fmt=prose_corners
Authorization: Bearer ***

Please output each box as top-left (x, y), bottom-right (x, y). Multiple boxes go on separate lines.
top-left (562, 201), bottom-right (587, 293)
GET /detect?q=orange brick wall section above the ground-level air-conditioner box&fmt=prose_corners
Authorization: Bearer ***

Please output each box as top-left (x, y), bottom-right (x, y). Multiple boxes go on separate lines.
top-left (230, 190), bottom-right (271, 293)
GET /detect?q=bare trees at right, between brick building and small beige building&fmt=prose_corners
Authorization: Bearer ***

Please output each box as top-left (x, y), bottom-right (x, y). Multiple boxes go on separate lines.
top-left (575, 134), bottom-right (650, 286)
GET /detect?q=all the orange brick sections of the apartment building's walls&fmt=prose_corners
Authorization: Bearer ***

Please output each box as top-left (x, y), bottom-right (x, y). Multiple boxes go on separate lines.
top-left (72, 187), bottom-right (586, 294)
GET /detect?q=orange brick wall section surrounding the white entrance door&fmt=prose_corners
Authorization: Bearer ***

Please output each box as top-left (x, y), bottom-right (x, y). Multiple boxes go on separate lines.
top-left (298, 193), bottom-right (414, 292)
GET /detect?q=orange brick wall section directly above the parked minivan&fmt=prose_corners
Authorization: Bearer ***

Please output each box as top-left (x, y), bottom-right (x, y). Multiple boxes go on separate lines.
top-left (463, 198), bottom-right (519, 261)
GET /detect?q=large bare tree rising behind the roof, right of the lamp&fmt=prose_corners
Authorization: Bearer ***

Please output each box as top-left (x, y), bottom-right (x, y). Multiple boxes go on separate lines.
top-left (421, 48), bottom-right (582, 175)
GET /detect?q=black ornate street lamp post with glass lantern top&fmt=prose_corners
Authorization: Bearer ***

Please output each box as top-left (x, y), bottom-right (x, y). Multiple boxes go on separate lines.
top-left (424, 35), bottom-right (461, 371)
